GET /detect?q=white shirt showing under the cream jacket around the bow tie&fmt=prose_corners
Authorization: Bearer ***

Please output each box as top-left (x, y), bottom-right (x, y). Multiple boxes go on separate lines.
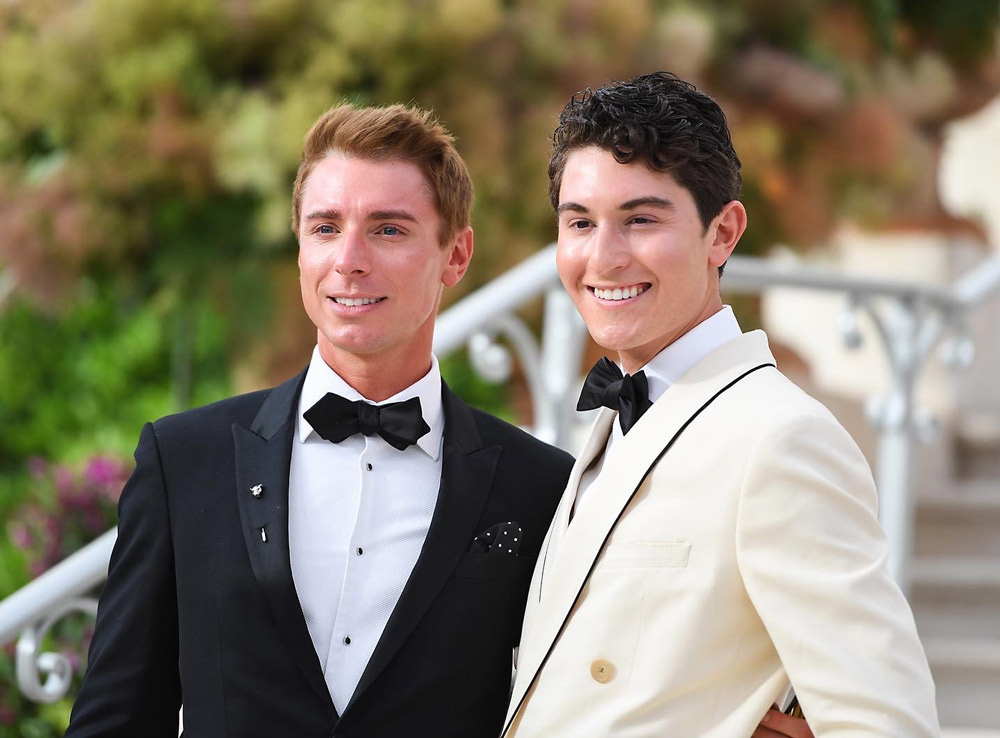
top-left (574, 305), bottom-right (743, 512)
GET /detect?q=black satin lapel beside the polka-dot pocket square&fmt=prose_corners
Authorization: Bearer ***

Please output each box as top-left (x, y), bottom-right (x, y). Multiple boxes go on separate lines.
top-left (345, 385), bottom-right (501, 713)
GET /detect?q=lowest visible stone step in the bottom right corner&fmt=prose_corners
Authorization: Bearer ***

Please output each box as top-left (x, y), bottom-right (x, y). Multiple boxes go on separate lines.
top-left (924, 637), bottom-right (1000, 730)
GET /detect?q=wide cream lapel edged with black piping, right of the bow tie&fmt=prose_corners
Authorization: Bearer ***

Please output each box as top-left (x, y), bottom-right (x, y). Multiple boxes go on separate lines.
top-left (505, 331), bottom-right (774, 730)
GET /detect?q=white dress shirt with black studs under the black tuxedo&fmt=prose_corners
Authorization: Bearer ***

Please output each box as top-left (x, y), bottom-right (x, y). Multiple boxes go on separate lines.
top-left (288, 347), bottom-right (444, 713)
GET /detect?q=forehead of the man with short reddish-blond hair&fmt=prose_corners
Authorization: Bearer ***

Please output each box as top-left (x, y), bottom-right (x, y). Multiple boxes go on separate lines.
top-left (302, 151), bottom-right (437, 216)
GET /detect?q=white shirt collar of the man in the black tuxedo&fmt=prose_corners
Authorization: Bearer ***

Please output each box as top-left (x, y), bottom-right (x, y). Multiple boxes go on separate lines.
top-left (296, 346), bottom-right (444, 461)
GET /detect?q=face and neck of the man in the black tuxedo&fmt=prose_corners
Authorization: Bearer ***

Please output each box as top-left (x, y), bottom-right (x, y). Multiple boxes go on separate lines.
top-left (298, 152), bottom-right (472, 392)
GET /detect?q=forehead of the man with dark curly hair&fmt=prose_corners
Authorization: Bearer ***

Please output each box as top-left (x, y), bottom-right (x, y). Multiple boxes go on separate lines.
top-left (559, 146), bottom-right (693, 205)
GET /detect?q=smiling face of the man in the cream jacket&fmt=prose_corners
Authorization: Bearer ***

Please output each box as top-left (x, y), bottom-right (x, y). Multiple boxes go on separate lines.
top-left (557, 146), bottom-right (746, 373)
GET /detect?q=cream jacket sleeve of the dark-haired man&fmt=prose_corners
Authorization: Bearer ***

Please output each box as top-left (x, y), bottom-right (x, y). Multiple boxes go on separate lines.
top-left (736, 408), bottom-right (940, 738)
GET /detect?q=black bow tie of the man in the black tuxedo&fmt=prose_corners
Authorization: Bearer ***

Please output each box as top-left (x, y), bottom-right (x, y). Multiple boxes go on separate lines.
top-left (302, 392), bottom-right (430, 451)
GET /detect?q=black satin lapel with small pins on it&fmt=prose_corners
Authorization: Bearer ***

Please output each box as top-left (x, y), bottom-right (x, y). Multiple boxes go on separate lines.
top-left (233, 372), bottom-right (334, 710)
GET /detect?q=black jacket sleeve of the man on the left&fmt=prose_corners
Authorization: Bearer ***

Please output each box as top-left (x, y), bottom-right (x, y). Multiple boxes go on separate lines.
top-left (66, 424), bottom-right (181, 738)
